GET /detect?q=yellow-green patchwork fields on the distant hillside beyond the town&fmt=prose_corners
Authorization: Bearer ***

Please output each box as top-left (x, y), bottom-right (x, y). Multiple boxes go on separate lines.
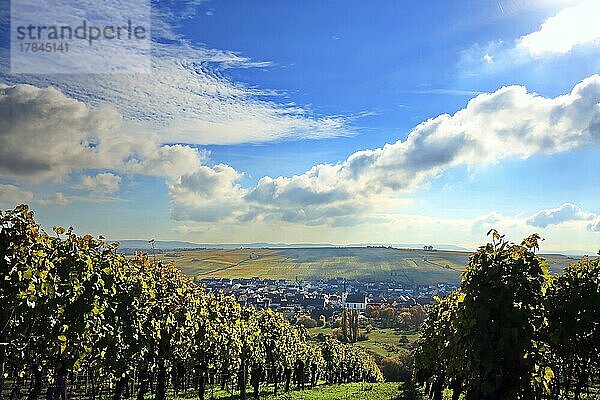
top-left (156, 247), bottom-right (574, 284)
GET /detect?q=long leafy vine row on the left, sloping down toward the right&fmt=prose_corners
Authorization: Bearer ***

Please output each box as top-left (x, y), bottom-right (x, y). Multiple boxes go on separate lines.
top-left (0, 205), bottom-right (382, 400)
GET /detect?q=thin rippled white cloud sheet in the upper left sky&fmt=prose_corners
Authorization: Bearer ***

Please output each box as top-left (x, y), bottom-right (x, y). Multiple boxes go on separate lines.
top-left (0, 2), bottom-right (353, 144)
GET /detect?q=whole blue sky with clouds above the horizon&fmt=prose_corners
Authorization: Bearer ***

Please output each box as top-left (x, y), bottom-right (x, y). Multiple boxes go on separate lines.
top-left (0, 0), bottom-right (600, 253)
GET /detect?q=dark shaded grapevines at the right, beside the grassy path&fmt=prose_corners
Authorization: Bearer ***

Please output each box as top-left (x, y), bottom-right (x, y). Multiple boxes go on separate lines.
top-left (414, 231), bottom-right (600, 400)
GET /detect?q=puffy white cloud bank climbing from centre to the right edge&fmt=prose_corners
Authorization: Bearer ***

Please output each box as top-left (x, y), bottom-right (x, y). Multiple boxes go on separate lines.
top-left (171, 75), bottom-right (600, 224)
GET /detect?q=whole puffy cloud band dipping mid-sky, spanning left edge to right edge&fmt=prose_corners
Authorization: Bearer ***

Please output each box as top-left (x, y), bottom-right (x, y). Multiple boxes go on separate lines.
top-left (0, 75), bottom-right (600, 226)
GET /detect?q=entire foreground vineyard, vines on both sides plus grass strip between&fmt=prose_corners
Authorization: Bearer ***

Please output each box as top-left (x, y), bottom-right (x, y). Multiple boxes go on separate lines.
top-left (0, 205), bottom-right (600, 400)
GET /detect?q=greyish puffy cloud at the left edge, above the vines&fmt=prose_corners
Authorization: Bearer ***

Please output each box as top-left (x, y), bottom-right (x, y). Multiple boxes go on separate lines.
top-left (0, 84), bottom-right (204, 181)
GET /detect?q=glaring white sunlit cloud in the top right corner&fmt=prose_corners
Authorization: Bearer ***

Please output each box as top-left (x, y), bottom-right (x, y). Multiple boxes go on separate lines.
top-left (517, 0), bottom-right (600, 58)
